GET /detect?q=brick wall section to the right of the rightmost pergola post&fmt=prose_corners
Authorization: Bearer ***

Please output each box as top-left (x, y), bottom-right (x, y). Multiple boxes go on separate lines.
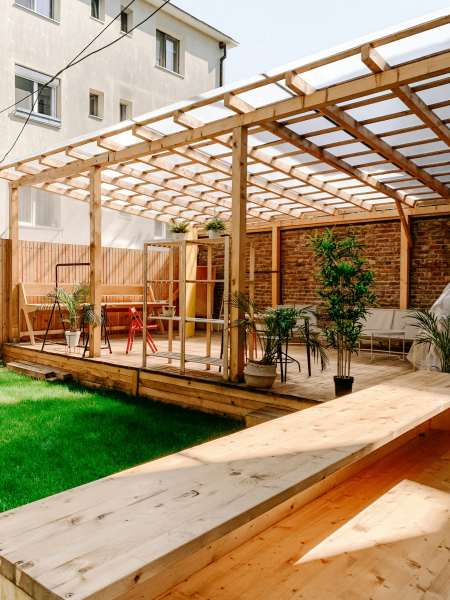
top-left (410, 217), bottom-right (450, 308)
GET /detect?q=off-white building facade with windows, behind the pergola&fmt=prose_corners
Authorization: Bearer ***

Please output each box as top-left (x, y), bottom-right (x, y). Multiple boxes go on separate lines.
top-left (0, 0), bottom-right (236, 248)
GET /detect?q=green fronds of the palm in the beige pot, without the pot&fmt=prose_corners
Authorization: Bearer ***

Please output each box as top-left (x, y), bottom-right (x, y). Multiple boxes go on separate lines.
top-left (231, 294), bottom-right (328, 369)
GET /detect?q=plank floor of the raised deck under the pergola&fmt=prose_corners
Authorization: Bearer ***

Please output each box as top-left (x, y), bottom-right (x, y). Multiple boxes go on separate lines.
top-left (9, 336), bottom-right (411, 402)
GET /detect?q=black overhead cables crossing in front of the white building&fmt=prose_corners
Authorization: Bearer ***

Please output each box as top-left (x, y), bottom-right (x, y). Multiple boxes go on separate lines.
top-left (0, 0), bottom-right (170, 164)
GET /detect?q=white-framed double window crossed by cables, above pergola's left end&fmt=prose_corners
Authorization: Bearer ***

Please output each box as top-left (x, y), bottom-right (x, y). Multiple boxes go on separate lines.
top-left (15, 66), bottom-right (60, 122)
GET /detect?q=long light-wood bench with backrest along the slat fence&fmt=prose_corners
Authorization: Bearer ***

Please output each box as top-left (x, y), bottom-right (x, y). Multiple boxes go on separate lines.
top-left (19, 282), bottom-right (166, 346)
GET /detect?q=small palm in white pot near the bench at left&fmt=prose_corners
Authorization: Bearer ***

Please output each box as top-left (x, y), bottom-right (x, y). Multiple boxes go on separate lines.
top-left (44, 284), bottom-right (99, 349)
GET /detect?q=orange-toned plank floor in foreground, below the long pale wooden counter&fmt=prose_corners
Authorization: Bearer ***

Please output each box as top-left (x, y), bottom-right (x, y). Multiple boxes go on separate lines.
top-left (161, 431), bottom-right (450, 600)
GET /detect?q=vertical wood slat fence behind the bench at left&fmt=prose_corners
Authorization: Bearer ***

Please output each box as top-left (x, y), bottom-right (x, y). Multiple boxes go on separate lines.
top-left (0, 240), bottom-right (168, 343)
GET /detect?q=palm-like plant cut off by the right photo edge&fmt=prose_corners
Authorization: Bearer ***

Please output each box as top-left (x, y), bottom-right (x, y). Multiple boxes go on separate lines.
top-left (411, 310), bottom-right (450, 373)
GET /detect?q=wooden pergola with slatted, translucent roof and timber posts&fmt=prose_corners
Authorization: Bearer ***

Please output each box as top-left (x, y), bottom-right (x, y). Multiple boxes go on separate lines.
top-left (0, 11), bottom-right (450, 379)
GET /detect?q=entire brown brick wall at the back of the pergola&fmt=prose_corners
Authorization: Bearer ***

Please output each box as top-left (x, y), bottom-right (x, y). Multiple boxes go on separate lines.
top-left (200, 217), bottom-right (450, 307)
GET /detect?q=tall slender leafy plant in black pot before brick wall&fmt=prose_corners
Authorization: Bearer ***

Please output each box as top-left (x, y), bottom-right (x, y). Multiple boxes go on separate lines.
top-left (311, 229), bottom-right (375, 397)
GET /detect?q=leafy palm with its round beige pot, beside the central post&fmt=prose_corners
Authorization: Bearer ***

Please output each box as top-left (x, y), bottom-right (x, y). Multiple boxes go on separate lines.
top-left (232, 294), bottom-right (327, 389)
